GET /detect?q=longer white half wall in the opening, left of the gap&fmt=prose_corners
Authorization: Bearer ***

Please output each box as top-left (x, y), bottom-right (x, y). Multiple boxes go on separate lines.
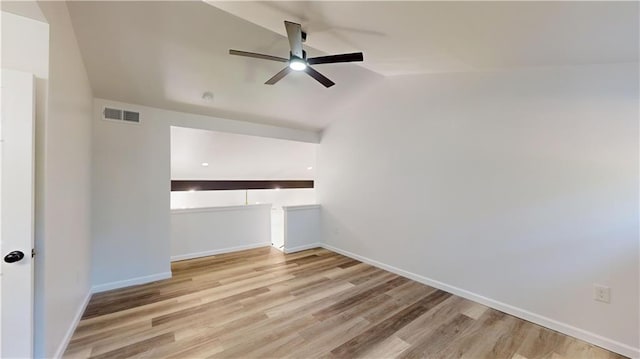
top-left (171, 205), bottom-right (271, 260)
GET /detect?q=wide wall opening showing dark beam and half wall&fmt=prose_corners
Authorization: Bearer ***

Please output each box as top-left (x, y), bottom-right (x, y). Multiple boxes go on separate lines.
top-left (171, 127), bottom-right (317, 260)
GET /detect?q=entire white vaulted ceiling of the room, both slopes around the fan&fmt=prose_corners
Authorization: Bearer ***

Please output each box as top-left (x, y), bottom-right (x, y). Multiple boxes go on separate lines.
top-left (68, 1), bottom-right (638, 130)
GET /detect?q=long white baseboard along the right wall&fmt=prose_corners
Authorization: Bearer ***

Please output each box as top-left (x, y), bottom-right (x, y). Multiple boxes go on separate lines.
top-left (320, 243), bottom-right (640, 358)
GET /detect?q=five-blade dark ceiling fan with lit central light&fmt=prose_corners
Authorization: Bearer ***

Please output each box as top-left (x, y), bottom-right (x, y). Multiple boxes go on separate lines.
top-left (229, 21), bottom-right (364, 87)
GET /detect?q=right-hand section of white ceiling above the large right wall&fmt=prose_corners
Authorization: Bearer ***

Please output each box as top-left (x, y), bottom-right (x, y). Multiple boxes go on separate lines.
top-left (208, 1), bottom-right (638, 76)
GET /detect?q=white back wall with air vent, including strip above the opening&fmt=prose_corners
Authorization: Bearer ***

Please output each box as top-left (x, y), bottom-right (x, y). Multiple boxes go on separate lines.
top-left (92, 99), bottom-right (319, 288)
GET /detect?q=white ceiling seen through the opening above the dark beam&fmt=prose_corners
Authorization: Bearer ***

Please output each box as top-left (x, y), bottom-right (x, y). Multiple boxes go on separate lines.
top-left (171, 127), bottom-right (317, 180)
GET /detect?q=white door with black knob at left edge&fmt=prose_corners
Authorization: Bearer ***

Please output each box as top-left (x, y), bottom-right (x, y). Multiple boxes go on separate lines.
top-left (0, 69), bottom-right (35, 358)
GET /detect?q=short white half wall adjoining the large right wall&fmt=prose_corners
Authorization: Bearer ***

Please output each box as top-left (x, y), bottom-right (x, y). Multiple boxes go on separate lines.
top-left (282, 205), bottom-right (321, 253)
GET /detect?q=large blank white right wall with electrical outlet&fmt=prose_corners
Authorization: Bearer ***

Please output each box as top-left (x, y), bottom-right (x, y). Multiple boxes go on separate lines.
top-left (316, 63), bottom-right (640, 356)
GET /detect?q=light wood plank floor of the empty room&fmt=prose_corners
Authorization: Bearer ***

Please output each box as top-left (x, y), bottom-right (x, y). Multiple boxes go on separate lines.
top-left (65, 248), bottom-right (622, 359)
